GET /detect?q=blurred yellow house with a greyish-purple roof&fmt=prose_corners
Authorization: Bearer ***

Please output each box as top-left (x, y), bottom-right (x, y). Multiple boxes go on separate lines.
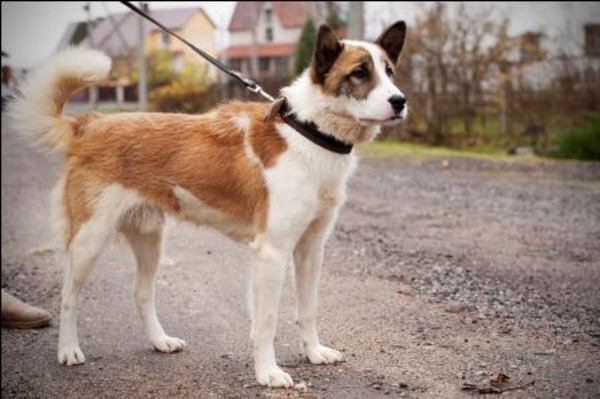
top-left (59, 7), bottom-right (216, 84)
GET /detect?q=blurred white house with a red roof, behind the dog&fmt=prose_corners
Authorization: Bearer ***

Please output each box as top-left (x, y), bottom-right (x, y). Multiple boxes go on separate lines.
top-left (220, 1), bottom-right (324, 78)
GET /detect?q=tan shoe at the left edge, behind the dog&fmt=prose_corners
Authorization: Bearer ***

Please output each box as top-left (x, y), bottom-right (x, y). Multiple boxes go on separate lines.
top-left (2, 290), bottom-right (52, 328)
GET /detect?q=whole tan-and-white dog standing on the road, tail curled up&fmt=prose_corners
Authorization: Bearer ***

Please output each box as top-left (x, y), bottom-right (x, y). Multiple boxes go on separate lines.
top-left (8, 21), bottom-right (408, 388)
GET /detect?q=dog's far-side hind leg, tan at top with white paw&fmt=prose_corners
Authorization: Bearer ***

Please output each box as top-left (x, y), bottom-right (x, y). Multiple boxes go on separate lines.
top-left (123, 224), bottom-right (185, 352)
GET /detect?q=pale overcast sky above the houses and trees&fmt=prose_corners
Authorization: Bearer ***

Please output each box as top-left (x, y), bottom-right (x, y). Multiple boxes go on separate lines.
top-left (2, 1), bottom-right (600, 68)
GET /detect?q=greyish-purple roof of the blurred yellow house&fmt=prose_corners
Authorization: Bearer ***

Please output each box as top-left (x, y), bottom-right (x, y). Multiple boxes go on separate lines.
top-left (90, 7), bottom-right (215, 57)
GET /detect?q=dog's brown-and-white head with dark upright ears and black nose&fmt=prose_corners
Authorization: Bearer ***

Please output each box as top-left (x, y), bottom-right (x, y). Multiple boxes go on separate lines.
top-left (310, 21), bottom-right (407, 126)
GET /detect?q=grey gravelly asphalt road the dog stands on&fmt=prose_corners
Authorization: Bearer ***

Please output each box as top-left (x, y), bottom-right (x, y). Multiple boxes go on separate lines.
top-left (2, 116), bottom-right (600, 398)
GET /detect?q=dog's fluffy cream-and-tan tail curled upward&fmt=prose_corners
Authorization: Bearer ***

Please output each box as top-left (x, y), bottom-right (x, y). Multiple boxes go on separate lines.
top-left (8, 47), bottom-right (111, 153)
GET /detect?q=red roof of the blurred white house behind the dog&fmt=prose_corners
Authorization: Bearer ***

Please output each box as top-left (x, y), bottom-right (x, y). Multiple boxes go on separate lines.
top-left (229, 1), bottom-right (314, 32)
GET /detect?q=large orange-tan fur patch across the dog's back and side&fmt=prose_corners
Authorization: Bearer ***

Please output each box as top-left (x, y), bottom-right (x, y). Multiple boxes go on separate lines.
top-left (65, 103), bottom-right (286, 240)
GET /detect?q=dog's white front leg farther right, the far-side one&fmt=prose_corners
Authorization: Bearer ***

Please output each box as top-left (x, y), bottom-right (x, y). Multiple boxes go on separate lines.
top-left (294, 211), bottom-right (342, 364)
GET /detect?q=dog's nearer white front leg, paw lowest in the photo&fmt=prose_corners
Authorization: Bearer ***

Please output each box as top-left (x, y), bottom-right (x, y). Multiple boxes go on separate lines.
top-left (251, 243), bottom-right (294, 388)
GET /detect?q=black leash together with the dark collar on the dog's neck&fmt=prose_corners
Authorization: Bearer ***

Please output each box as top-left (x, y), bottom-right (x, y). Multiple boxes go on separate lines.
top-left (121, 1), bottom-right (352, 154)
